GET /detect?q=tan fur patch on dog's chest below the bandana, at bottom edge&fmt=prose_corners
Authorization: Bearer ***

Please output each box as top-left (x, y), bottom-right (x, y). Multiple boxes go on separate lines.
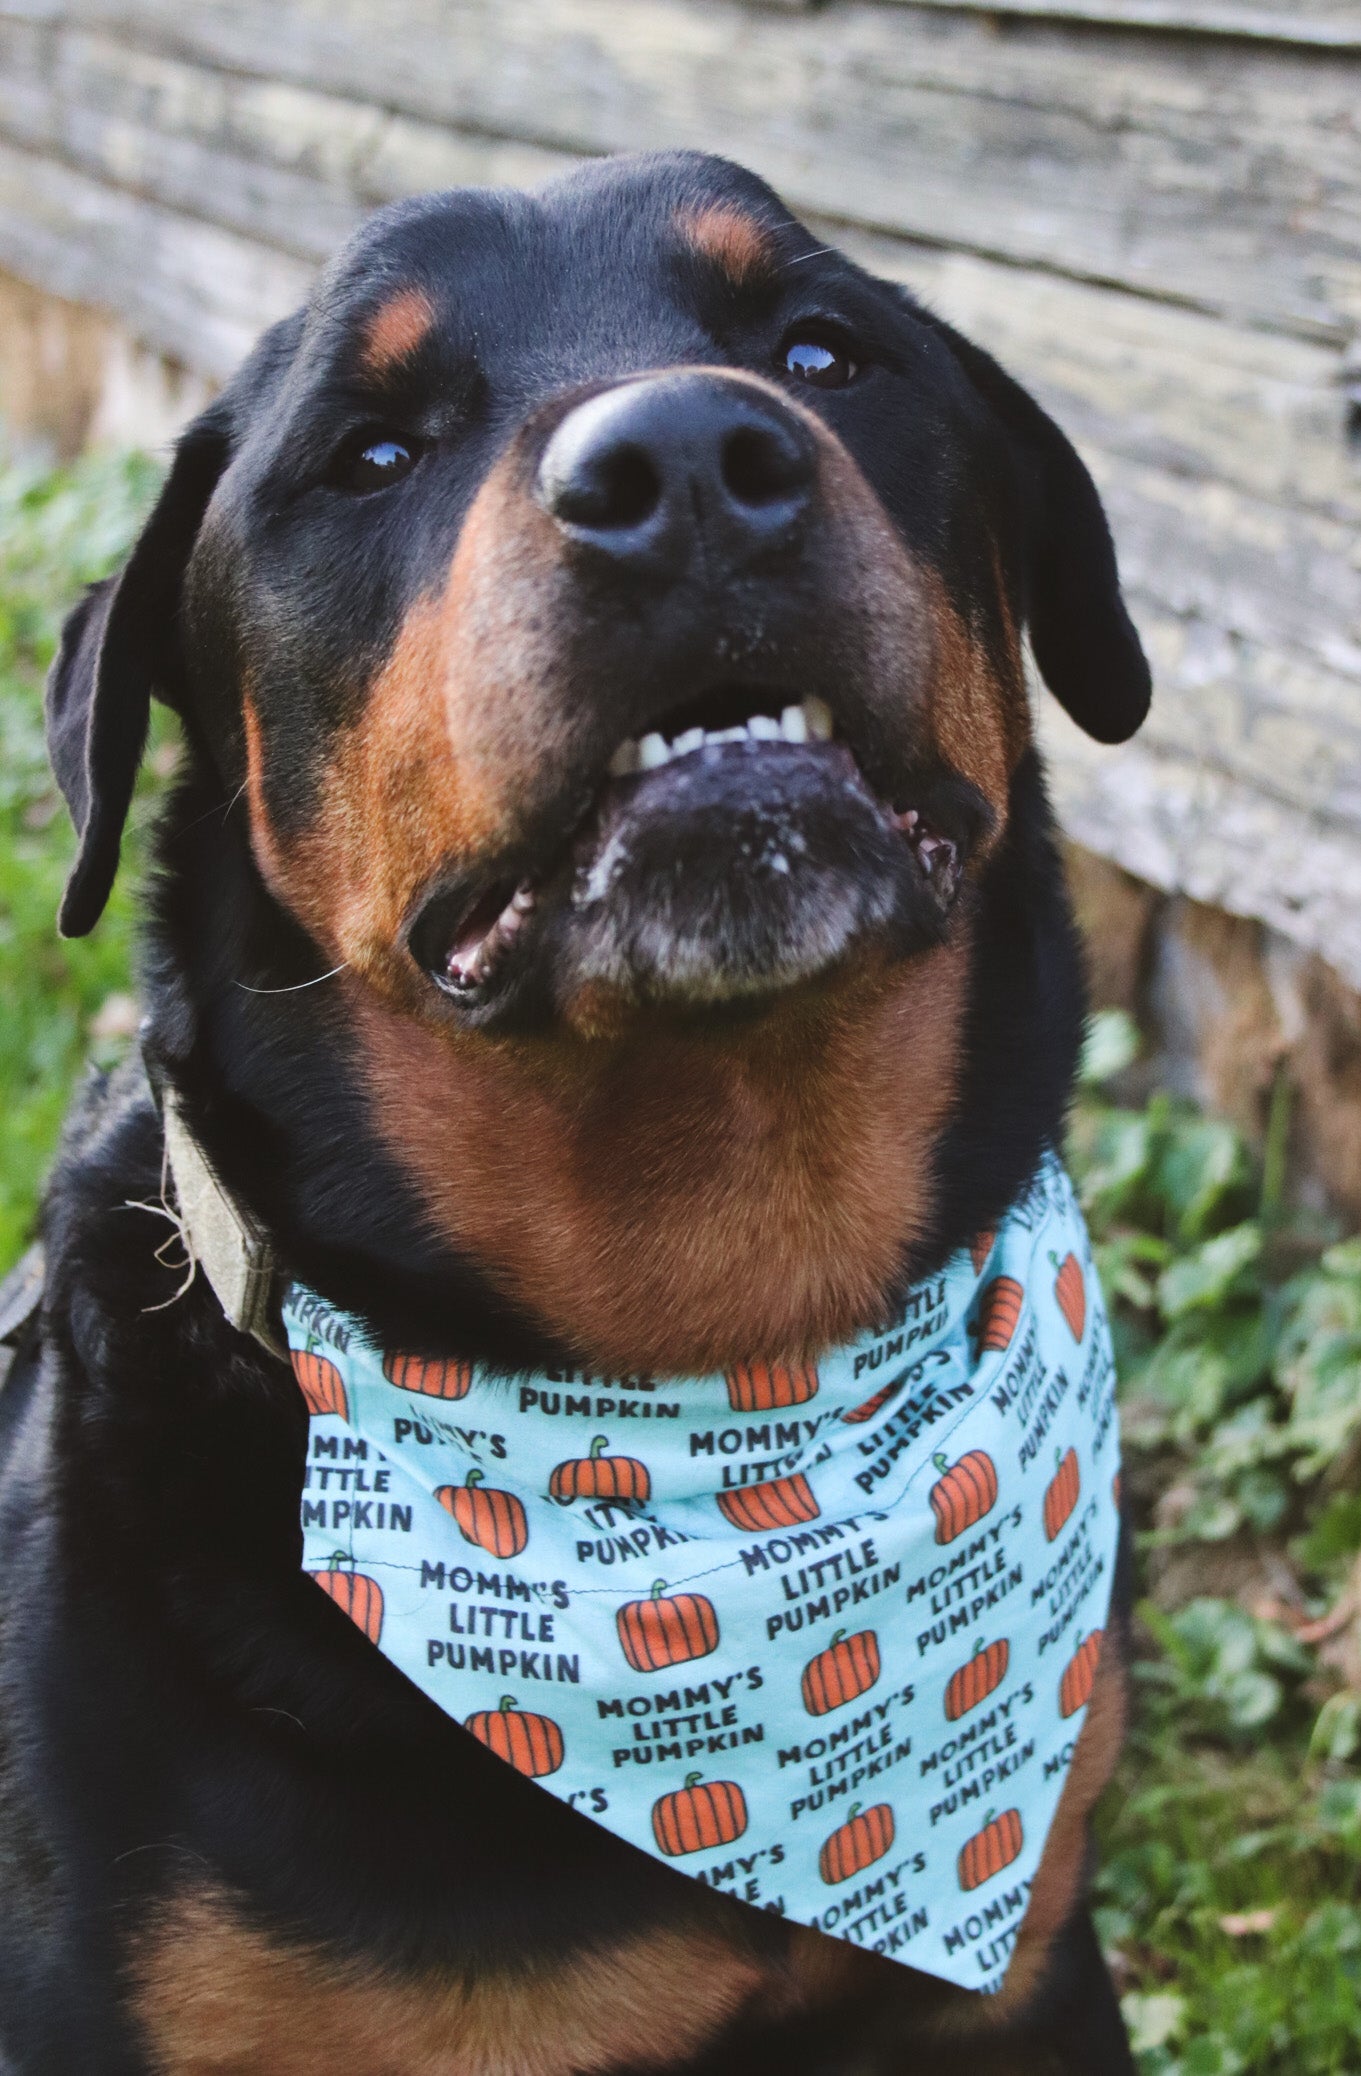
top-left (129, 1883), bottom-right (770, 2076)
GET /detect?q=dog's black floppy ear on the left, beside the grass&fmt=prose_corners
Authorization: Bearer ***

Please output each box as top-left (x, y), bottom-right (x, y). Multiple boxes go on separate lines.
top-left (46, 409), bottom-right (228, 936)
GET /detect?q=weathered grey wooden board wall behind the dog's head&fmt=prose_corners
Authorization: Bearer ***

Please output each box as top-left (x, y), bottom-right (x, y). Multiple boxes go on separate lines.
top-left (0, 0), bottom-right (1361, 984)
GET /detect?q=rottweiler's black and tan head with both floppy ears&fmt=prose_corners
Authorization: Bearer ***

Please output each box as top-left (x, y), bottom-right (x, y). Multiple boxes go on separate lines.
top-left (50, 154), bottom-right (1149, 1358)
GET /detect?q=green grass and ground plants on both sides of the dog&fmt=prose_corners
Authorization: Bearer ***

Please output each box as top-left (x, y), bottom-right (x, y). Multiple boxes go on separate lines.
top-left (0, 442), bottom-right (1361, 2076)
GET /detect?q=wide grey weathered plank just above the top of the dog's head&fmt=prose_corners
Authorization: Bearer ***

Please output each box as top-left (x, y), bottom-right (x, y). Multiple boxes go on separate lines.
top-left (53, 0), bottom-right (1361, 343)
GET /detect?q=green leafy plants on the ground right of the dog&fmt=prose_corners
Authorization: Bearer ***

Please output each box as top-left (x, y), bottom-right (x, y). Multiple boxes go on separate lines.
top-left (1068, 1015), bottom-right (1361, 2076)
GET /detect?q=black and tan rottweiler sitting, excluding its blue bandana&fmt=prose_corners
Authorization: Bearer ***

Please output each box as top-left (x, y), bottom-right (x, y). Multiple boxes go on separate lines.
top-left (0, 156), bottom-right (1147, 2076)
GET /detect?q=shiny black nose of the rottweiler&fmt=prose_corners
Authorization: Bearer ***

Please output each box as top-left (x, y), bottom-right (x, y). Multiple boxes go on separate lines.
top-left (537, 372), bottom-right (815, 577)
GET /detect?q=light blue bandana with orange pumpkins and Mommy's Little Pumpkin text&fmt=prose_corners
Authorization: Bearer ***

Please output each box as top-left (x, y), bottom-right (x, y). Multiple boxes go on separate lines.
top-left (284, 1154), bottom-right (1118, 1991)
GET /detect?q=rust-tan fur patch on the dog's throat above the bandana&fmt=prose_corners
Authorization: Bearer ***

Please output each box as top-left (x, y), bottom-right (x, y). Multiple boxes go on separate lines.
top-left (353, 945), bottom-right (965, 1374)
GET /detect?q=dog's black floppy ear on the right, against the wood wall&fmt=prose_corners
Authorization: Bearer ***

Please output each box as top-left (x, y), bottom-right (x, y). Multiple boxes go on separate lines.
top-left (940, 324), bottom-right (1151, 743)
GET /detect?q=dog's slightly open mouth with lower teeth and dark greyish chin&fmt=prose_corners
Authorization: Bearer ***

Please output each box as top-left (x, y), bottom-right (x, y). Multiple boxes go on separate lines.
top-left (409, 685), bottom-right (979, 1011)
